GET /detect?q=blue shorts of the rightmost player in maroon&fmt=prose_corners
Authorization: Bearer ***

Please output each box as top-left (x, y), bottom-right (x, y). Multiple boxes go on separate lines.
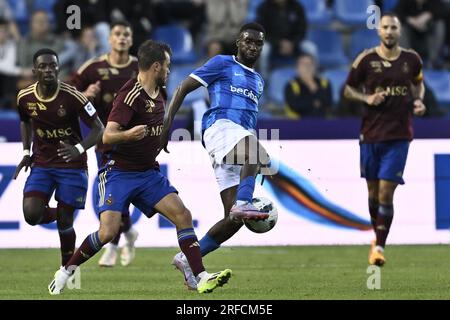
top-left (360, 140), bottom-right (409, 184)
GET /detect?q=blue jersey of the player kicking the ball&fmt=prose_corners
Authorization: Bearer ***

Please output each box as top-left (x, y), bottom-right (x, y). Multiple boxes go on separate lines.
top-left (190, 55), bottom-right (264, 132)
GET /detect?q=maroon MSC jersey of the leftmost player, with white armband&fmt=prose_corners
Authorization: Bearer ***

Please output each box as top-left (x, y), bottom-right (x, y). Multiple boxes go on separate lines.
top-left (17, 82), bottom-right (97, 169)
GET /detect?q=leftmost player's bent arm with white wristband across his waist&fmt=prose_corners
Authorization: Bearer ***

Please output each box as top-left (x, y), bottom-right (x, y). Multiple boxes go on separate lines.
top-left (57, 116), bottom-right (104, 162)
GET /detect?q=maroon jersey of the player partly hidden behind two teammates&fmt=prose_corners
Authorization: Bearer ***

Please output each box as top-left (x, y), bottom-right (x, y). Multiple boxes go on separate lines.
top-left (71, 54), bottom-right (138, 126)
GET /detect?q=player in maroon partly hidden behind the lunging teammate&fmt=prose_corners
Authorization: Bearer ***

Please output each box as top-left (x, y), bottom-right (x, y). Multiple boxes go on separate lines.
top-left (71, 21), bottom-right (138, 267)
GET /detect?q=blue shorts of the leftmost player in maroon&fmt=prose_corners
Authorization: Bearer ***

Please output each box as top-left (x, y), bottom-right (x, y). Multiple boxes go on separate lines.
top-left (23, 167), bottom-right (88, 209)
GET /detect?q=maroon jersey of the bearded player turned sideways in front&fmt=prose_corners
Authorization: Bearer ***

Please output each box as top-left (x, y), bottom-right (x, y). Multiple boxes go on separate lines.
top-left (106, 79), bottom-right (167, 171)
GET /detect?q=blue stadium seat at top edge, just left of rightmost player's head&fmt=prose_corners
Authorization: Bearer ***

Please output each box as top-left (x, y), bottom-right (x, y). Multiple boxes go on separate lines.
top-left (333, 0), bottom-right (374, 26)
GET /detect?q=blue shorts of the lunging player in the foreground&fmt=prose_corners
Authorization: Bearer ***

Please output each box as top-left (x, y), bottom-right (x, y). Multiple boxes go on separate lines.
top-left (96, 167), bottom-right (178, 218)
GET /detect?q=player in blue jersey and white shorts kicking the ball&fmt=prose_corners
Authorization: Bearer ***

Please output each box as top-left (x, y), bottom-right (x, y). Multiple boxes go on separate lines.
top-left (160, 23), bottom-right (269, 290)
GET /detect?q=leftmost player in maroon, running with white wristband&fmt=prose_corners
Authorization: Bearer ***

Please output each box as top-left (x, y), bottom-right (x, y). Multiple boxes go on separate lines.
top-left (14, 49), bottom-right (103, 265)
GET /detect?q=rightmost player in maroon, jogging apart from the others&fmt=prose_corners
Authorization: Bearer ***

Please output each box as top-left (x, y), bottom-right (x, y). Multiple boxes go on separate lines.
top-left (345, 14), bottom-right (426, 266)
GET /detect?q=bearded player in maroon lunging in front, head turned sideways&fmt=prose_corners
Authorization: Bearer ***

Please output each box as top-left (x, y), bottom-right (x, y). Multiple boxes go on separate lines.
top-left (48, 40), bottom-right (231, 294)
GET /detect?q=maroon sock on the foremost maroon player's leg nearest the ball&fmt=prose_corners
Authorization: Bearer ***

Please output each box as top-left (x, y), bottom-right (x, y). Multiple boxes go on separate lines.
top-left (177, 228), bottom-right (205, 276)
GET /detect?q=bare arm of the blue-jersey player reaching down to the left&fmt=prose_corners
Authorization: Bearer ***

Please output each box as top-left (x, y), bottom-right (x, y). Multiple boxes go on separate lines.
top-left (158, 77), bottom-right (202, 153)
